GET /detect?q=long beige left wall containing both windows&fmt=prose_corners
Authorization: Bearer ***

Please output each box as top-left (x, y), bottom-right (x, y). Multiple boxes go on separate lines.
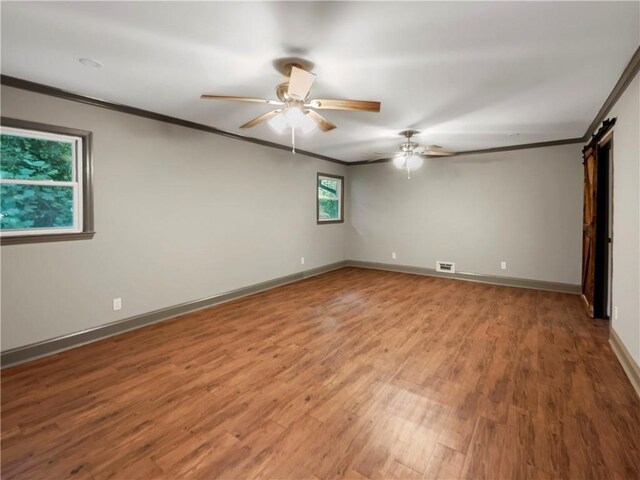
top-left (1, 87), bottom-right (347, 350)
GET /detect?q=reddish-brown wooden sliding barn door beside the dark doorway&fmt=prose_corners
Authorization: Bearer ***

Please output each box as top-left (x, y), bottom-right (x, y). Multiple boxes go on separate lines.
top-left (582, 145), bottom-right (598, 316)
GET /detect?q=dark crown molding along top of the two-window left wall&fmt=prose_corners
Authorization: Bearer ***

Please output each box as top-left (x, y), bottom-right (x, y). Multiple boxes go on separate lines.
top-left (0, 75), bottom-right (349, 165)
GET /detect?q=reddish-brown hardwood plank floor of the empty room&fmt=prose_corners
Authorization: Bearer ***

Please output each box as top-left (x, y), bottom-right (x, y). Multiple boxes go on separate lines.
top-left (1, 268), bottom-right (640, 480)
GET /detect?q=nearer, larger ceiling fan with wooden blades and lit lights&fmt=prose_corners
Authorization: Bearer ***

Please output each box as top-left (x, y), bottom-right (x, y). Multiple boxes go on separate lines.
top-left (200, 62), bottom-right (380, 153)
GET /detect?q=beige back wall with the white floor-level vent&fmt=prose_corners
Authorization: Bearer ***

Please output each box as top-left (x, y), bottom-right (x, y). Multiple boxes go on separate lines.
top-left (348, 144), bottom-right (582, 284)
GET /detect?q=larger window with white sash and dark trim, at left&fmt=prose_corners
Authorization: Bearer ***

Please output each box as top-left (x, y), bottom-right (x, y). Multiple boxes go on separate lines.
top-left (0, 118), bottom-right (93, 244)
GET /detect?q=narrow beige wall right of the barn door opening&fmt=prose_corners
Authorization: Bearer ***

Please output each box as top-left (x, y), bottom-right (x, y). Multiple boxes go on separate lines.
top-left (608, 70), bottom-right (640, 365)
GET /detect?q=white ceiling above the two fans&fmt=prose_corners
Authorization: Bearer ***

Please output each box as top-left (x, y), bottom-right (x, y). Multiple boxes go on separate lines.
top-left (1, 1), bottom-right (640, 161)
